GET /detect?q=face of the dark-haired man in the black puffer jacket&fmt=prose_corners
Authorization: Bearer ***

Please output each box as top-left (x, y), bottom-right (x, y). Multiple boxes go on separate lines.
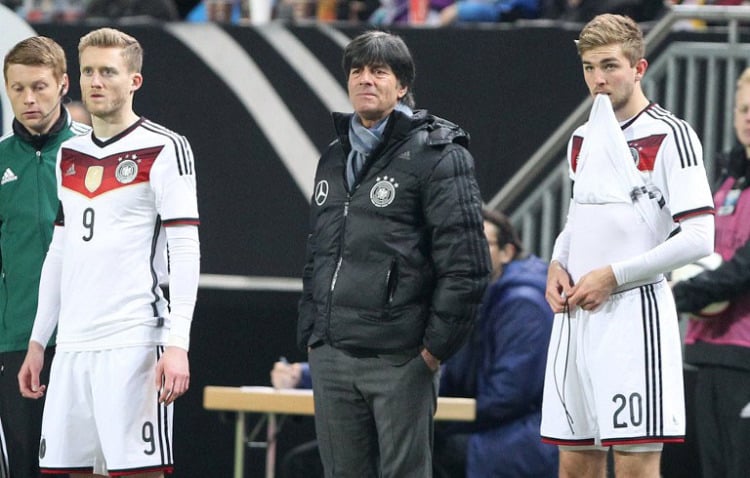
top-left (348, 65), bottom-right (408, 128)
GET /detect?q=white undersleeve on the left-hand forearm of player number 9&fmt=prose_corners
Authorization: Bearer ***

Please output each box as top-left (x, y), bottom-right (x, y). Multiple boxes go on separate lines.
top-left (31, 226), bottom-right (63, 347)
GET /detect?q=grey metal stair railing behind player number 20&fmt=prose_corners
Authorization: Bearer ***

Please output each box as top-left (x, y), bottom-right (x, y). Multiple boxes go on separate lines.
top-left (487, 5), bottom-right (750, 259)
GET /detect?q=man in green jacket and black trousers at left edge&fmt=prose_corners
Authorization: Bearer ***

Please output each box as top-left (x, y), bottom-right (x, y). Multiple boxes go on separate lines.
top-left (0, 36), bottom-right (88, 478)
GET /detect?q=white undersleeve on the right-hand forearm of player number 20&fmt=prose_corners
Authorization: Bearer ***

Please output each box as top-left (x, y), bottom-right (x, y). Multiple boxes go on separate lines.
top-left (612, 214), bottom-right (714, 285)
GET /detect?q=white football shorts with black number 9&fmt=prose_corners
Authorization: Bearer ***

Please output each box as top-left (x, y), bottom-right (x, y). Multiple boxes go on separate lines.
top-left (39, 345), bottom-right (173, 476)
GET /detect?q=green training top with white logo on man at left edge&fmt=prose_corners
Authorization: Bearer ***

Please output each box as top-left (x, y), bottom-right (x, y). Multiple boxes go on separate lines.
top-left (0, 106), bottom-right (90, 352)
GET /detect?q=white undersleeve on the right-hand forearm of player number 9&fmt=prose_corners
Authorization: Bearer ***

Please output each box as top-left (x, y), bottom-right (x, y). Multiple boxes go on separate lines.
top-left (165, 226), bottom-right (200, 350)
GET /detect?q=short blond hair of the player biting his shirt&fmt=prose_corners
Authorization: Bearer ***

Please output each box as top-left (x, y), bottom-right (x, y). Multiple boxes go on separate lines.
top-left (576, 13), bottom-right (646, 66)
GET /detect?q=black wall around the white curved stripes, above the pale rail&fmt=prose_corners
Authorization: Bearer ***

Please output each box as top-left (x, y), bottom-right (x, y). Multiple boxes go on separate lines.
top-left (30, 25), bottom-right (586, 277)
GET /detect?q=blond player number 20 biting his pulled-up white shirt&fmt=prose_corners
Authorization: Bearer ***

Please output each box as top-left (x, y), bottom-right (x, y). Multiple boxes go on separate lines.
top-left (541, 14), bottom-right (714, 478)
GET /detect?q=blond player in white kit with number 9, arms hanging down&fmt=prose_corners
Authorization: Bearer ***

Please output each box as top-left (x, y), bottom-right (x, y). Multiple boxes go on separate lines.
top-left (19, 28), bottom-right (200, 478)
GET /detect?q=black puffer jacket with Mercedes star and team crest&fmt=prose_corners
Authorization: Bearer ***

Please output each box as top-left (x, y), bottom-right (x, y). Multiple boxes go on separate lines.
top-left (297, 111), bottom-right (490, 360)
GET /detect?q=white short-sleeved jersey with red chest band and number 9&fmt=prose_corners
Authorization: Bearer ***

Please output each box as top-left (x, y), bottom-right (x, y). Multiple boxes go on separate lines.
top-left (57, 118), bottom-right (199, 350)
